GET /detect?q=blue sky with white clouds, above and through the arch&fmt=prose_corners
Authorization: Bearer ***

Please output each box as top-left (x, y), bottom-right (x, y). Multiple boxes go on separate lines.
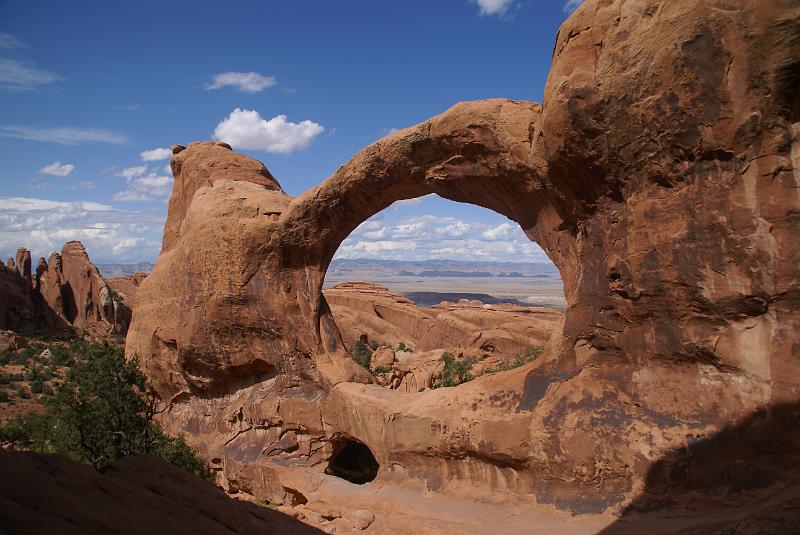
top-left (0, 0), bottom-right (576, 262)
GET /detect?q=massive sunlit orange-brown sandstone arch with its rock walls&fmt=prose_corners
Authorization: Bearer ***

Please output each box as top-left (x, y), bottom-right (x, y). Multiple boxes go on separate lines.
top-left (127, 0), bottom-right (800, 511)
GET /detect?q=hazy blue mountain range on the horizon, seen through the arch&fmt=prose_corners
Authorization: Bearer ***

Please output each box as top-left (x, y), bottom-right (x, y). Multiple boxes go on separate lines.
top-left (326, 258), bottom-right (559, 280)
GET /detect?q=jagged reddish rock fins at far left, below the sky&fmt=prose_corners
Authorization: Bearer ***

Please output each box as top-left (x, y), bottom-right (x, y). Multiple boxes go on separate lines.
top-left (0, 241), bottom-right (130, 336)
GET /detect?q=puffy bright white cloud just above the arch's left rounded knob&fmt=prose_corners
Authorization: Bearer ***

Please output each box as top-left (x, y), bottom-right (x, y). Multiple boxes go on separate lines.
top-left (214, 108), bottom-right (325, 154)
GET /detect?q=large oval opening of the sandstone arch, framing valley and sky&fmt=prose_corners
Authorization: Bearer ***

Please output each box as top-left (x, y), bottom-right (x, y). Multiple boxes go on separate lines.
top-left (323, 194), bottom-right (566, 393)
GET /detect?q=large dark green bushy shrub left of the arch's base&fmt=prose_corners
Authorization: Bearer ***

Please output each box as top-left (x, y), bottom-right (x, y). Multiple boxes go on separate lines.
top-left (0, 343), bottom-right (211, 479)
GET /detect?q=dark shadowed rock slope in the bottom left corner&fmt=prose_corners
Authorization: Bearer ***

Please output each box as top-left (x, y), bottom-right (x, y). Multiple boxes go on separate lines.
top-left (0, 448), bottom-right (323, 535)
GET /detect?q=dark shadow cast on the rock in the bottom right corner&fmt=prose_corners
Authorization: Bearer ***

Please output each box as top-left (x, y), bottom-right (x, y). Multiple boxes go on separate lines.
top-left (600, 403), bottom-right (800, 535)
